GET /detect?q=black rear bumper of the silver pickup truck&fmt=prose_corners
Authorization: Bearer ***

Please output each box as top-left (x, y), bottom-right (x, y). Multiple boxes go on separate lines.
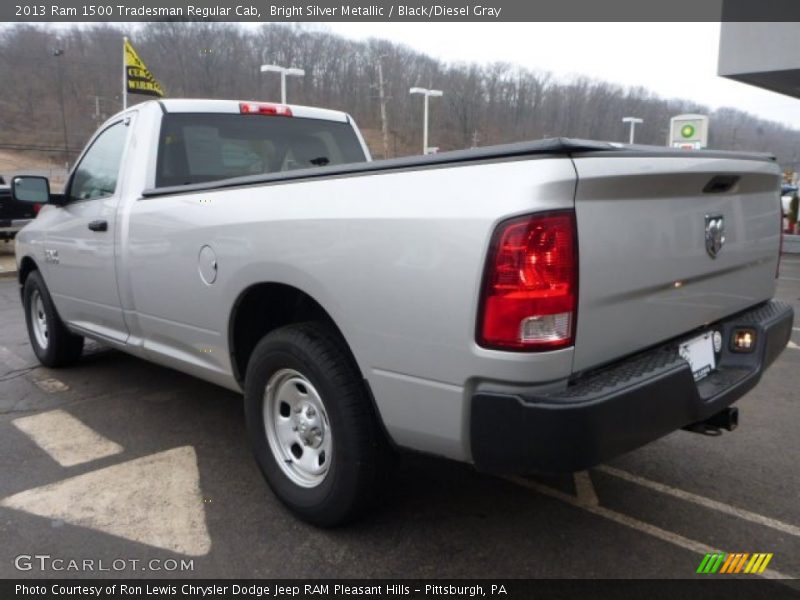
top-left (470, 300), bottom-right (794, 473)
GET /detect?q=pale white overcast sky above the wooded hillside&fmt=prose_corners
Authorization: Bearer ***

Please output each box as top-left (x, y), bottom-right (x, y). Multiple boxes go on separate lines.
top-left (320, 23), bottom-right (800, 129)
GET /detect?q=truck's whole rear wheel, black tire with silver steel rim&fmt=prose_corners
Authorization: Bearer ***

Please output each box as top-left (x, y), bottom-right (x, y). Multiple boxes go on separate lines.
top-left (245, 323), bottom-right (388, 527)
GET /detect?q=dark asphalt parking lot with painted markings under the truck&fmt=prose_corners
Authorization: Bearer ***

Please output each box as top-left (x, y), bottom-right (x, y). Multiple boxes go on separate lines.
top-left (0, 247), bottom-right (800, 578)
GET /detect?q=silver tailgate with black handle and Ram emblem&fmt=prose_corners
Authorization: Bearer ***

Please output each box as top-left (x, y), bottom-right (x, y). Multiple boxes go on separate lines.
top-left (573, 153), bottom-right (780, 371)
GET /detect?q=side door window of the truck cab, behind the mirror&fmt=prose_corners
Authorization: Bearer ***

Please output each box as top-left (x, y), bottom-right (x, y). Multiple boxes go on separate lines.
top-left (69, 121), bottom-right (127, 200)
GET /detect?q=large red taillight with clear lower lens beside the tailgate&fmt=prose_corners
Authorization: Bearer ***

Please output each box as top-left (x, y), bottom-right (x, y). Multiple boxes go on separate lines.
top-left (478, 211), bottom-right (578, 350)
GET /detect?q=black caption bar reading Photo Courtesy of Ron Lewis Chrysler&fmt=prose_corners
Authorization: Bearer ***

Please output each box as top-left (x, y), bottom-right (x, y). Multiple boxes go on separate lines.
top-left (0, 576), bottom-right (798, 600)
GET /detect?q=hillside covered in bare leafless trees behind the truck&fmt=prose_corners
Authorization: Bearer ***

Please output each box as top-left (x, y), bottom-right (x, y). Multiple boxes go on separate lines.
top-left (0, 22), bottom-right (800, 168)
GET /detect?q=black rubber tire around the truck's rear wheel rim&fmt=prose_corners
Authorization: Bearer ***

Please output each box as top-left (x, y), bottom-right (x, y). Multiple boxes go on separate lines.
top-left (245, 323), bottom-right (391, 527)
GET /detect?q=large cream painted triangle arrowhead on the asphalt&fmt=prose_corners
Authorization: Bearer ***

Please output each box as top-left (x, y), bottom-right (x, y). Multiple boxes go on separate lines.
top-left (0, 446), bottom-right (211, 556)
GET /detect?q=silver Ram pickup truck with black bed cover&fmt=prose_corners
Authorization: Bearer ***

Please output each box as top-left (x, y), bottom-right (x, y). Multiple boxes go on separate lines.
top-left (12, 100), bottom-right (793, 525)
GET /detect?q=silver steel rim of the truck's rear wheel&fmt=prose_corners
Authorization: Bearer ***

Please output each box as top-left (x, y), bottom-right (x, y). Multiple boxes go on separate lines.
top-left (263, 369), bottom-right (333, 488)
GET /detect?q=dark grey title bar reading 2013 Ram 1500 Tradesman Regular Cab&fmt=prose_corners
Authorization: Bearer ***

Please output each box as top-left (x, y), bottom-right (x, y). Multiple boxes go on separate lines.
top-left (7, 0), bottom-right (800, 22)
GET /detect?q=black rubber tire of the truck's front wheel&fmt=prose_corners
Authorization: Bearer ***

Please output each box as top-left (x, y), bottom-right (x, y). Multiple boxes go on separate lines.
top-left (22, 271), bottom-right (83, 367)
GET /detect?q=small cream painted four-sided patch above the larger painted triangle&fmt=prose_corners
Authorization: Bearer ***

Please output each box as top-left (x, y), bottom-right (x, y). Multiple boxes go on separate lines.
top-left (12, 410), bottom-right (123, 467)
